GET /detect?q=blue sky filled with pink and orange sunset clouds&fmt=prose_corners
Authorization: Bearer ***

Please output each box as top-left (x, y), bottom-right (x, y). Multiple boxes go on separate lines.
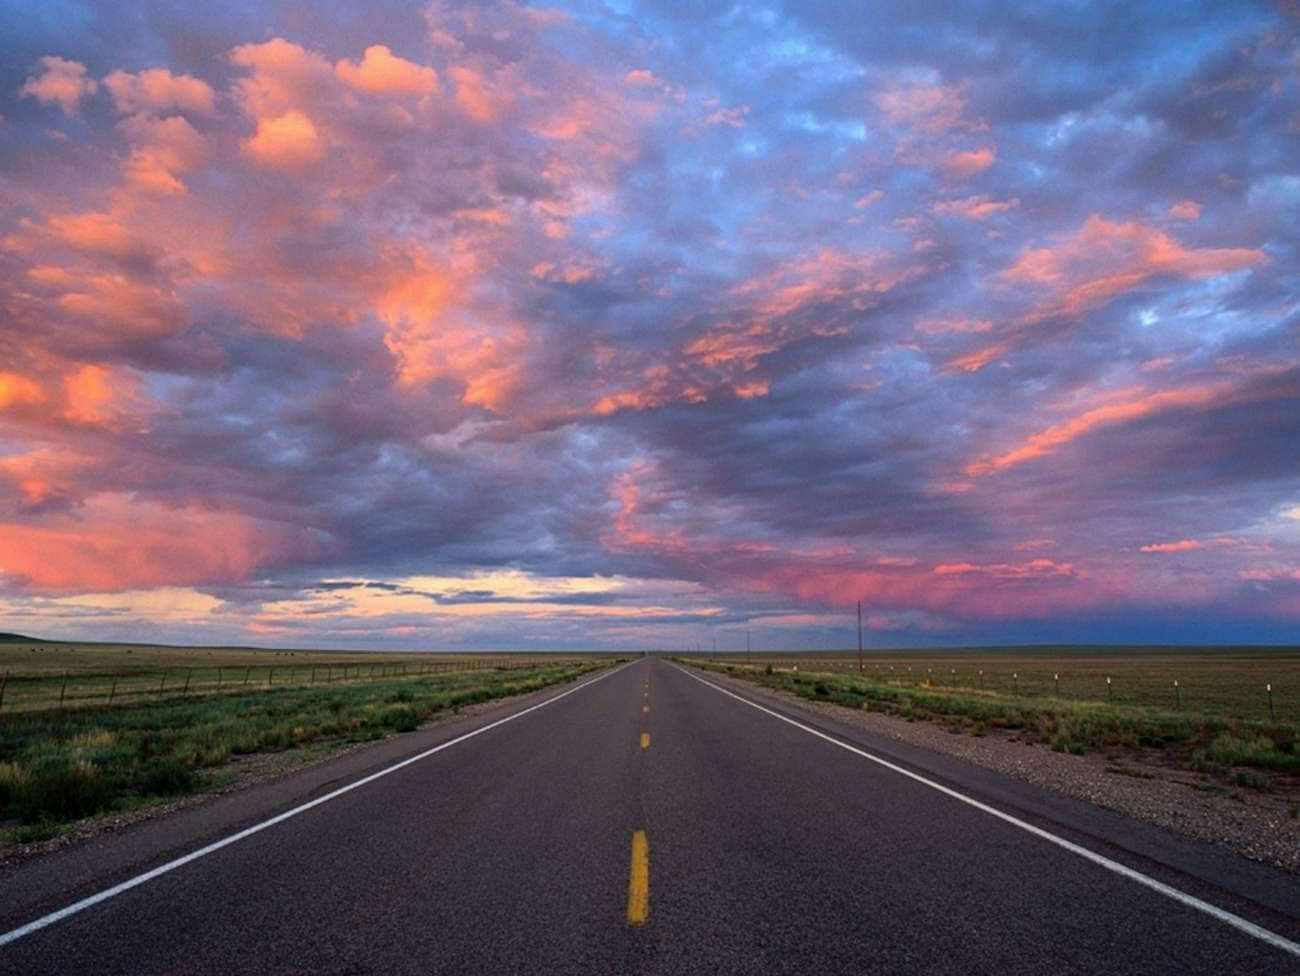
top-left (0, 0), bottom-right (1300, 650)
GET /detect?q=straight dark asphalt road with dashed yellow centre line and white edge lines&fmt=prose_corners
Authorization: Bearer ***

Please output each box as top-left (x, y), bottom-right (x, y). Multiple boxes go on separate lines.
top-left (0, 659), bottom-right (1300, 976)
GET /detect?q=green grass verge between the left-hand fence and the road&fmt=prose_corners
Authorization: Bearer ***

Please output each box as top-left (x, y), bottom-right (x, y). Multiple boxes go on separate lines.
top-left (0, 659), bottom-right (607, 841)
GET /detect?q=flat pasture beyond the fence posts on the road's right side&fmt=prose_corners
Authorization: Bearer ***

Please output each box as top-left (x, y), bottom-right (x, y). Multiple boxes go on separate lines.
top-left (686, 646), bottom-right (1300, 725)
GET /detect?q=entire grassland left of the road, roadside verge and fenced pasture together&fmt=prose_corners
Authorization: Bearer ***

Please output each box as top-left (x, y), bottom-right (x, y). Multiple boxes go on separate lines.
top-left (0, 645), bottom-right (615, 843)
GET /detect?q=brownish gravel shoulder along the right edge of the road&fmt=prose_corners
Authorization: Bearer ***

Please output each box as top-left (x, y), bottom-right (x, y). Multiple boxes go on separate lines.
top-left (709, 672), bottom-right (1300, 873)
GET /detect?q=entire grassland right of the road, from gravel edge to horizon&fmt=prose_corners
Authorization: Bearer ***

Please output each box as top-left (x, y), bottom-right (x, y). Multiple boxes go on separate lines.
top-left (679, 649), bottom-right (1300, 788)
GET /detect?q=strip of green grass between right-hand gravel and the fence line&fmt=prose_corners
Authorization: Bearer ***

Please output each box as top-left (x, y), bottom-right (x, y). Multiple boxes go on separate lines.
top-left (683, 659), bottom-right (1300, 786)
